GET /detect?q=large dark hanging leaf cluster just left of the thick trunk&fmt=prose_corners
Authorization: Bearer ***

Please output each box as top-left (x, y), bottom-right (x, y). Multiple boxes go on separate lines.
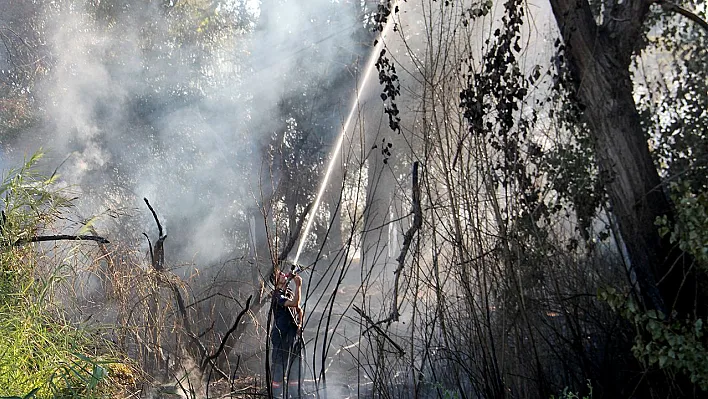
top-left (459, 0), bottom-right (552, 241)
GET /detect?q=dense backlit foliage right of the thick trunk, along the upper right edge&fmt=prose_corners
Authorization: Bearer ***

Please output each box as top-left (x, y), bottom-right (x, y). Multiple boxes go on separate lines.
top-left (635, 1), bottom-right (708, 189)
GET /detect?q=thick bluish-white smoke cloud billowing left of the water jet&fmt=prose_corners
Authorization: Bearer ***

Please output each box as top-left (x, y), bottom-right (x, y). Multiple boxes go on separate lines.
top-left (5, 0), bottom-right (355, 263)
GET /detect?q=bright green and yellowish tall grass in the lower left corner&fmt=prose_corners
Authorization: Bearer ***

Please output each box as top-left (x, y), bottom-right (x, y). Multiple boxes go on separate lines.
top-left (0, 153), bottom-right (119, 398)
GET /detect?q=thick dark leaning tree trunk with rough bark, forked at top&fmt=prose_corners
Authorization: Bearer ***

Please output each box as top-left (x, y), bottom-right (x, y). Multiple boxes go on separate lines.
top-left (550, 0), bottom-right (695, 315)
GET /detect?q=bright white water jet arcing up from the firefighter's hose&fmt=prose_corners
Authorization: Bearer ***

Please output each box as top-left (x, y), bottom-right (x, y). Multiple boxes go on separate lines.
top-left (293, 4), bottom-right (398, 264)
